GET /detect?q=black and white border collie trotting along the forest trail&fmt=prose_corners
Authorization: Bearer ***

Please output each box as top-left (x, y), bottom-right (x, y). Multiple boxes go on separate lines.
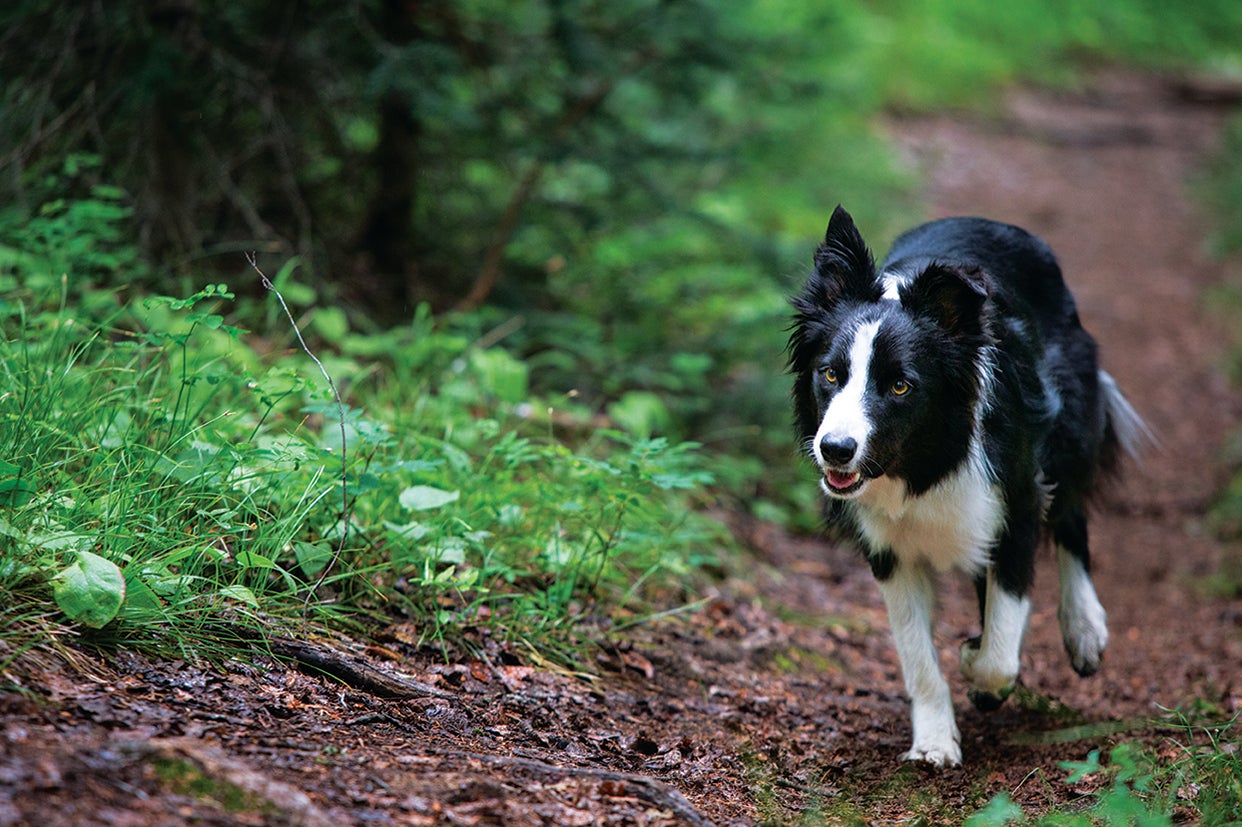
top-left (789, 206), bottom-right (1146, 766)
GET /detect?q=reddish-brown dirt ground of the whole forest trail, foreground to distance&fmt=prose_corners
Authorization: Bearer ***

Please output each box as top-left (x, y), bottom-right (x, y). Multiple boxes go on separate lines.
top-left (7, 73), bottom-right (1242, 827)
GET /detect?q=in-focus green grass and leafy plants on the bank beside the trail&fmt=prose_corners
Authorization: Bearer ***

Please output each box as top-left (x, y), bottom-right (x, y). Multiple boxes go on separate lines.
top-left (0, 191), bottom-right (724, 659)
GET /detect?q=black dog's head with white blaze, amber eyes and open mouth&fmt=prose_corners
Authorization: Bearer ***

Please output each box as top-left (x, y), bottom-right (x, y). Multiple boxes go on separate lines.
top-left (789, 206), bottom-right (991, 499)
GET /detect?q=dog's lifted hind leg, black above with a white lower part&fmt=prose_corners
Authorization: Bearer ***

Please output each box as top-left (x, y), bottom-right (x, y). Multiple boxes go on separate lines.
top-left (1053, 510), bottom-right (1108, 677)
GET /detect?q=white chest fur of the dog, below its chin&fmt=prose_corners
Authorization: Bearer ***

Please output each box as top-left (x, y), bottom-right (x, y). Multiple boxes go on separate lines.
top-left (856, 437), bottom-right (1005, 574)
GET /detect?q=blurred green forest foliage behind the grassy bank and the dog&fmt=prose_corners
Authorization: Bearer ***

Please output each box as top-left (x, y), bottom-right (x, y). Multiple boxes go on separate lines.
top-left (0, 0), bottom-right (1242, 630)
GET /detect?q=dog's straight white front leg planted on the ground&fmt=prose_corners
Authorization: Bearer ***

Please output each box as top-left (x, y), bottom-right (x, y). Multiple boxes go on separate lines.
top-left (877, 560), bottom-right (961, 766)
